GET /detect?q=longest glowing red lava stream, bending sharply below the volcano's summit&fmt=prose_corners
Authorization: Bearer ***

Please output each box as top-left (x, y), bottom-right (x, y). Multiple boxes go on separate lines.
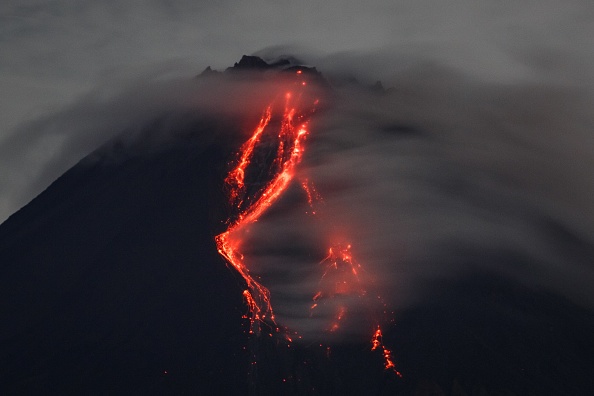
top-left (215, 71), bottom-right (317, 333)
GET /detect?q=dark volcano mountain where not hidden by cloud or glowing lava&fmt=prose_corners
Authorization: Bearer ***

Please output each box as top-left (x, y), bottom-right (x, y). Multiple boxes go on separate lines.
top-left (0, 57), bottom-right (594, 395)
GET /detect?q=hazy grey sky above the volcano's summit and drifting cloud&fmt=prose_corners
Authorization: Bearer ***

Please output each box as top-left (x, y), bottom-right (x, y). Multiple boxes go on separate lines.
top-left (0, 0), bottom-right (594, 221)
